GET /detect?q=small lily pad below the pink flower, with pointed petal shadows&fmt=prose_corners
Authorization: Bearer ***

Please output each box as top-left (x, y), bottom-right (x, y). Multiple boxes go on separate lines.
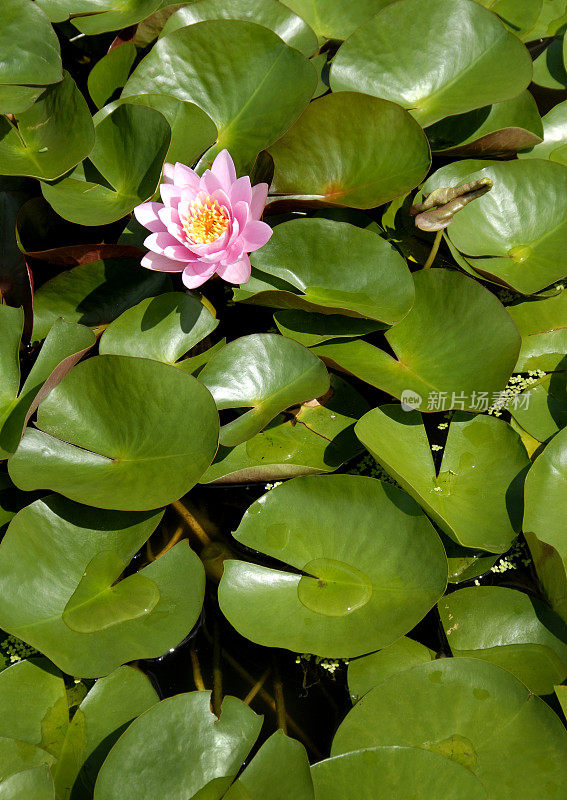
top-left (99, 292), bottom-right (219, 364)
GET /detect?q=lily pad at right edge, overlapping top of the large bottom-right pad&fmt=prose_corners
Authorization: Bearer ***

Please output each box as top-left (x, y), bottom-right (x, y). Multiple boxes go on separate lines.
top-left (437, 586), bottom-right (567, 695)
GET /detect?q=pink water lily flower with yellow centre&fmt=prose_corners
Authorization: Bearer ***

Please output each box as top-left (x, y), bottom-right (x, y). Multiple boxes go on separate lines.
top-left (134, 150), bottom-right (272, 289)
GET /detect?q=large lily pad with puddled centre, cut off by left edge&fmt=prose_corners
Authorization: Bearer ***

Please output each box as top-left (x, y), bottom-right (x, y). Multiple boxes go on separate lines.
top-left (0, 495), bottom-right (205, 676)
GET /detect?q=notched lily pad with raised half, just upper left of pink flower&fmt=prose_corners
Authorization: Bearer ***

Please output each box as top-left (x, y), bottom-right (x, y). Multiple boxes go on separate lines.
top-left (41, 104), bottom-right (171, 225)
